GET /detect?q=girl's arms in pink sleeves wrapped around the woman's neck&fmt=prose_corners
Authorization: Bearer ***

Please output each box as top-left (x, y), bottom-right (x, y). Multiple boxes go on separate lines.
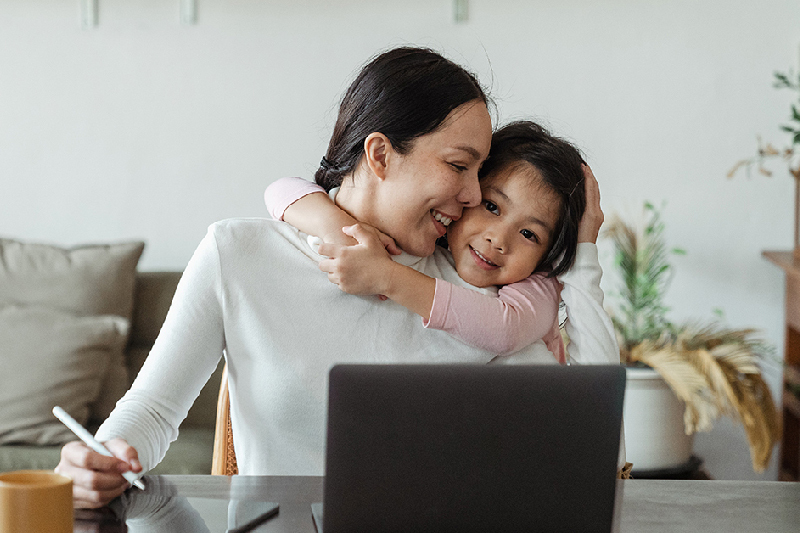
top-left (272, 178), bottom-right (563, 357)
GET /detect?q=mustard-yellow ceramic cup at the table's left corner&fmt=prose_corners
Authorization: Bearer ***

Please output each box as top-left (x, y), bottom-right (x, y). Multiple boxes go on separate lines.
top-left (0, 470), bottom-right (73, 533)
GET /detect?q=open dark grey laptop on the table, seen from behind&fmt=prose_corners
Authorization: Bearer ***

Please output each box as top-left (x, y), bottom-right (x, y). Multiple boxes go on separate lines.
top-left (313, 364), bottom-right (625, 533)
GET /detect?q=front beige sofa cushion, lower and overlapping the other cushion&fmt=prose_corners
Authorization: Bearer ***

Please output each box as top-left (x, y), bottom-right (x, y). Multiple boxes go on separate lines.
top-left (0, 305), bottom-right (128, 445)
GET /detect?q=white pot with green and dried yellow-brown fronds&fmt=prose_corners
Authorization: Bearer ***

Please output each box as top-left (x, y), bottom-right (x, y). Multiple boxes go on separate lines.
top-left (604, 203), bottom-right (781, 472)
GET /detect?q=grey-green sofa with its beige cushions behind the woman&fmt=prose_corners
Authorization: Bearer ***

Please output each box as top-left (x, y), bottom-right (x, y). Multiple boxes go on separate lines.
top-left (0, 239), bottom-right (223, 474)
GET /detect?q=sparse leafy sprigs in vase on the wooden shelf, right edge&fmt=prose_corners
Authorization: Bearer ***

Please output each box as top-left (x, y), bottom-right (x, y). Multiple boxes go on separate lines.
top-left (728, 71), bottom-right (800, 261)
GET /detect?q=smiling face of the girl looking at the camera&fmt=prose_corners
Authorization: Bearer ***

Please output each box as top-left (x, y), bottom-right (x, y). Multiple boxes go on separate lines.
top-left (447, 163), bottom-right (561, 287)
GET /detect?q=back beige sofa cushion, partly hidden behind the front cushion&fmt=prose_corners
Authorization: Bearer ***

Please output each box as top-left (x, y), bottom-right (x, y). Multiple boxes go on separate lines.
top-left (0, 238), bottom-right (144, 420)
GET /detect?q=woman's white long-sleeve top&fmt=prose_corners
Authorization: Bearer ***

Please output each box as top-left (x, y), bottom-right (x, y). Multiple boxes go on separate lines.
top-left (97, 219), bottom-right (619, 475)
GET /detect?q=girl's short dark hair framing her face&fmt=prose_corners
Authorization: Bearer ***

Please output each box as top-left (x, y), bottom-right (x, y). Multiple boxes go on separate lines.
top-left (480, 120), bottom-right (586, 277)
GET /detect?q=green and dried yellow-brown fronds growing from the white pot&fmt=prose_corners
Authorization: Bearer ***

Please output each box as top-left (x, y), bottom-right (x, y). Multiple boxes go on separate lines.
top-left (603, 202), bottom-right (781, 472)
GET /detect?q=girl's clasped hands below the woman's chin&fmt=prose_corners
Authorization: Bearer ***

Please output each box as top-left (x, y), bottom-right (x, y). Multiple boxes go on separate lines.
top-left (319, 223), bottom-right (400, 295)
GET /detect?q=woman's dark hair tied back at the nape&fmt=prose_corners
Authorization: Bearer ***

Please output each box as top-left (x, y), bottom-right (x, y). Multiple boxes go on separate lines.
top-left (314, 47), bottom-right (488, 191)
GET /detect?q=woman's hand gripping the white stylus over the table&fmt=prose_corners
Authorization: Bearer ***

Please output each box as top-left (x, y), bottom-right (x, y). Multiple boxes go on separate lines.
top-left (55, 439), bottom-right (142, 508)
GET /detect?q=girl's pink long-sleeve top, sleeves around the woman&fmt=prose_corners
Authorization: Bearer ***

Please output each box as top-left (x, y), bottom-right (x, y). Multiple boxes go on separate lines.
top-left (264, 178), bottom-right (566, 364)
